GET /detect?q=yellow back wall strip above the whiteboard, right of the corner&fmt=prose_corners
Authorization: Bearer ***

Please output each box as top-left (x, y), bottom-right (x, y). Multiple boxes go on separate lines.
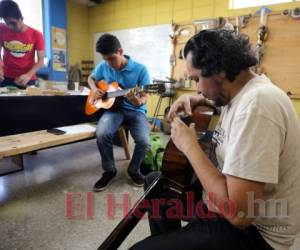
top-left (89, 0), bottom-right (300, 33)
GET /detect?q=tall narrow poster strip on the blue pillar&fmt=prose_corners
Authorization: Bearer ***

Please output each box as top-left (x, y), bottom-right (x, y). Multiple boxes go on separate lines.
top-left (52, 27), bottom-right (67, 72)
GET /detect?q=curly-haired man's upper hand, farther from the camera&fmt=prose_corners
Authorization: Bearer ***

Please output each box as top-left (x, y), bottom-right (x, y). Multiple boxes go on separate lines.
top-left (167, 95), bottom-right (192, 122)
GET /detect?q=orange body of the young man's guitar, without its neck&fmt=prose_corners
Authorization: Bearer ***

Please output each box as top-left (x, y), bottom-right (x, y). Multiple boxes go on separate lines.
top-left (85, 80), bottom-right (121, 115)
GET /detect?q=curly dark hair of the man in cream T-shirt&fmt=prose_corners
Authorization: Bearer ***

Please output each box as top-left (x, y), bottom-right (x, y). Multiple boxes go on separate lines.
top-left (184, 29), bottom-right (257, 82)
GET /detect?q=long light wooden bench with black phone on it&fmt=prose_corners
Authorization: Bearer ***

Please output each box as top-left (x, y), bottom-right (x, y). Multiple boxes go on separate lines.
top-left (0, 123), bottom-right (130, 176)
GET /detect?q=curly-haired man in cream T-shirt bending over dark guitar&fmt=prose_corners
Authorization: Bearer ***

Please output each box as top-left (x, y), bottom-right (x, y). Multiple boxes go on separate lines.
top-left (131, 30), bottom-right (300, 250)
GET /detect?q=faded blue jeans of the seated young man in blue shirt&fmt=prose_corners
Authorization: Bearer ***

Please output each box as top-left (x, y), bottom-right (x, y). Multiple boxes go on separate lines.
top-left (96, 108), bottom-right (150, 174)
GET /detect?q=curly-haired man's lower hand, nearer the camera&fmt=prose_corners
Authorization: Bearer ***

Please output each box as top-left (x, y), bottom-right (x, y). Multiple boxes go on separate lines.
top-left (171, 117), bottom-right (198, 155)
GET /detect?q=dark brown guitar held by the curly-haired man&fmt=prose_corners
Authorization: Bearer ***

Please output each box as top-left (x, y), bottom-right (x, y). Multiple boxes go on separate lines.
top-left (98, 106), bottom-right (215, 250)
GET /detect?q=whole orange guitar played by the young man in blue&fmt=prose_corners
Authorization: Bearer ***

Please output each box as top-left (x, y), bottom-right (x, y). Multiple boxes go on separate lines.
top-left (85, 80), bottom-right (165, 115)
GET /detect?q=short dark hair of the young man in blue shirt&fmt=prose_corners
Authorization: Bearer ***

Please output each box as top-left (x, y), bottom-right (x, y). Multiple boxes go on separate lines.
top-left (96, 33), bottom-right (121, 55)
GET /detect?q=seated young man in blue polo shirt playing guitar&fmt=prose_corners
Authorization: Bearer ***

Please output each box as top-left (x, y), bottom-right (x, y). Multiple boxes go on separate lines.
top-left (88, 34), bottom-right (150, 191)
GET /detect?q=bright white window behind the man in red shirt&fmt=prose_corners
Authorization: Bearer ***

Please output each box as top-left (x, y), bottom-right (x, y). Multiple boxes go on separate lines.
top-left (14, 0), bottom-right (43, 32)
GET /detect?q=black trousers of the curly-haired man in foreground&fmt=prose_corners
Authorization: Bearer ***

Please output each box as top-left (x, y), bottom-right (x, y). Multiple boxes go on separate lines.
top-left (130, 172), bottom-right (273, 250)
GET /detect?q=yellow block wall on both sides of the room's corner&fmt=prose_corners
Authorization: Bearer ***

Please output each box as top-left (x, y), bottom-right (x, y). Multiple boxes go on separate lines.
top-left (68, 0), bottom-right (300, 117)
